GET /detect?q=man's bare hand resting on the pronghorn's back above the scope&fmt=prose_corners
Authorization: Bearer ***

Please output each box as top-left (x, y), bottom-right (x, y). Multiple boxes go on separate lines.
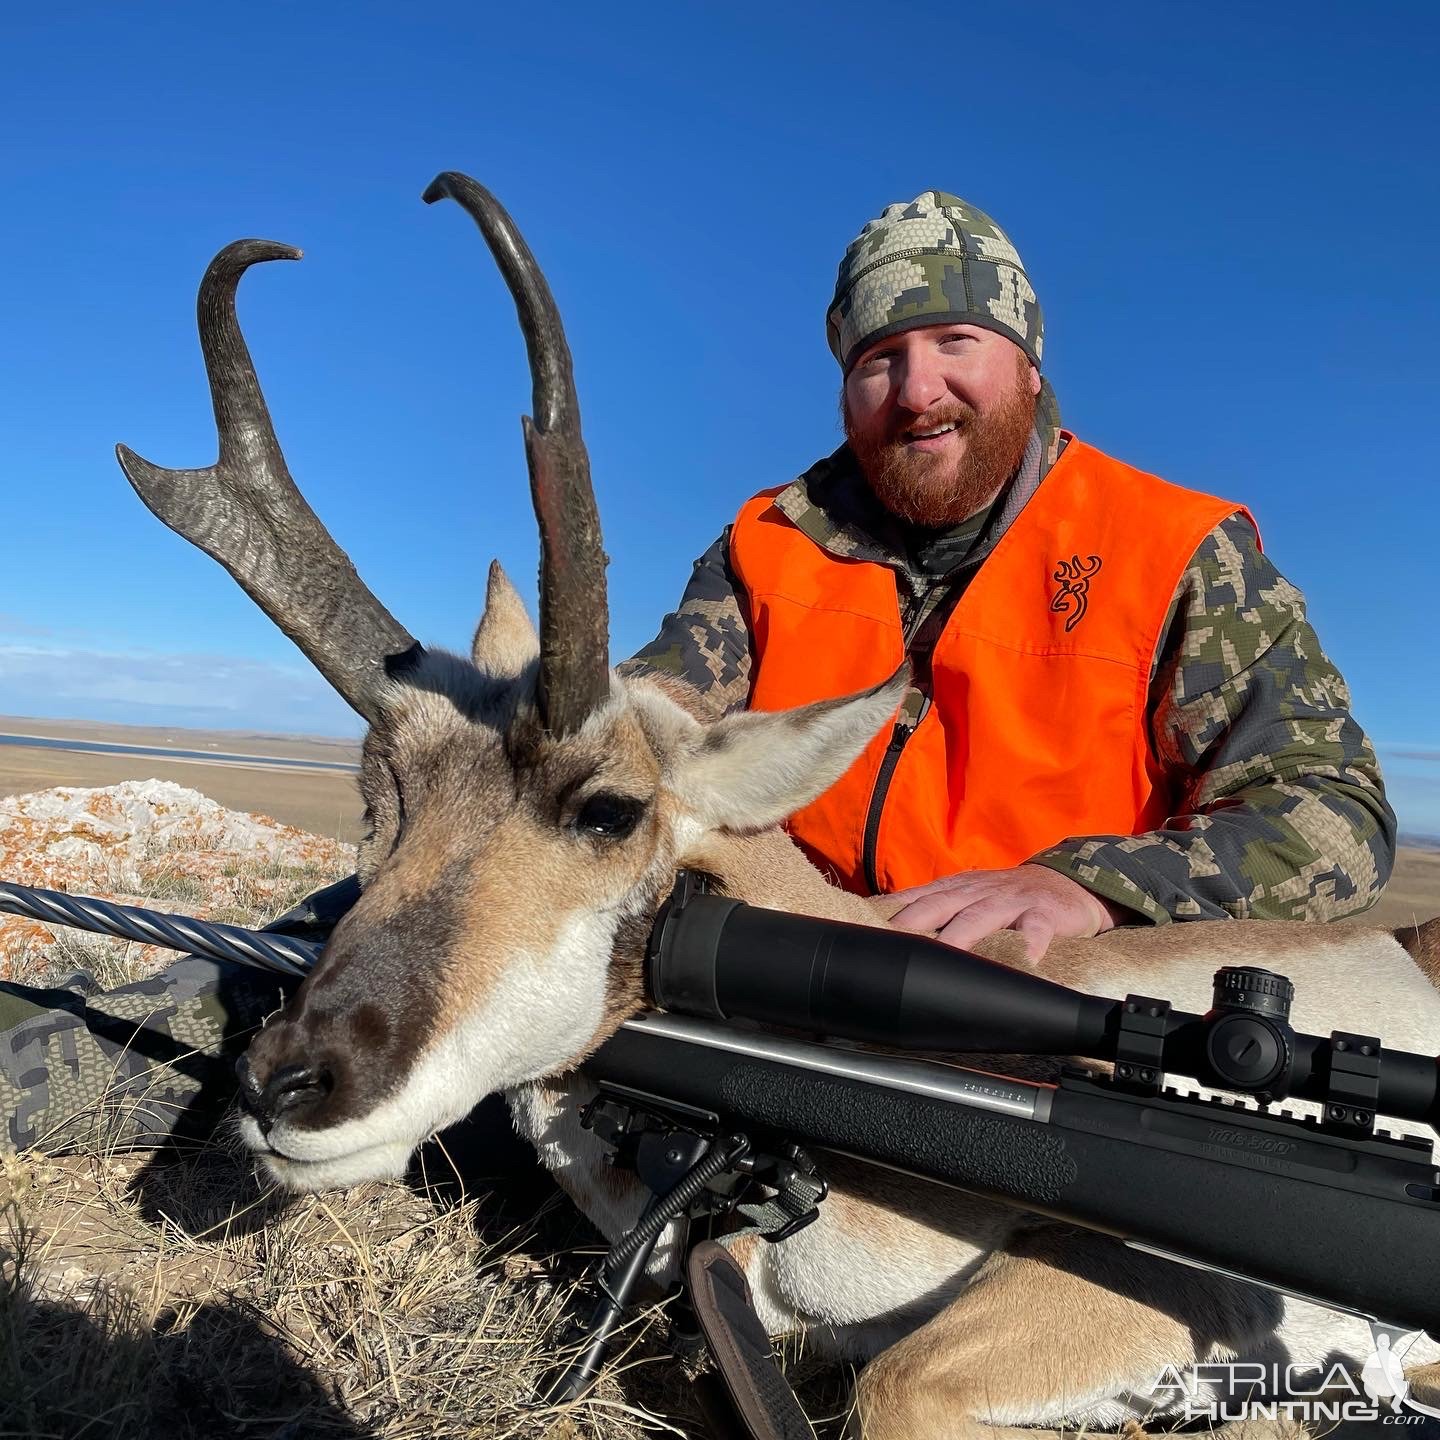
top-left (890, 865), bottom-right (1126, 965)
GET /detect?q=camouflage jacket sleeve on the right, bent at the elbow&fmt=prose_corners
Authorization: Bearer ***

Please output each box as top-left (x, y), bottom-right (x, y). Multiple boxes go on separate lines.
top-left (1034, 516), bottom-right (1395, 923)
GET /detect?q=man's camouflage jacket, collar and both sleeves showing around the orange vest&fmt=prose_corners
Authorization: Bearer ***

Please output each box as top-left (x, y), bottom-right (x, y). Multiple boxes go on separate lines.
top-left (622, 400), bottom-right (1395, 923)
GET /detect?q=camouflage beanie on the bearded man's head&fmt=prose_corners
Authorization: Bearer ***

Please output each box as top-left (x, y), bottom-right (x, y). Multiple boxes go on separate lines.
top-left (825, 190), bottom-right (1045, 370)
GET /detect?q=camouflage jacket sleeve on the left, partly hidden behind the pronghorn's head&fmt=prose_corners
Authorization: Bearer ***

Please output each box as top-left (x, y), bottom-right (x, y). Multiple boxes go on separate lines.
top-left (618, 526), bottom-right (750, 714)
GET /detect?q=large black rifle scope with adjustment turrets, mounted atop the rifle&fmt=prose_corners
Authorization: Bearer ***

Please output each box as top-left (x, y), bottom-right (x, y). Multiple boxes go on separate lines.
top-left (647, 874), bottom-right (1440, 1129)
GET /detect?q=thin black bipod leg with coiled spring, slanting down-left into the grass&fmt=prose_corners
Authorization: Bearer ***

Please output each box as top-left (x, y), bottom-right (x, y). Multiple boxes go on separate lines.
top-left (541, 1132), bottom-right (750, 1405)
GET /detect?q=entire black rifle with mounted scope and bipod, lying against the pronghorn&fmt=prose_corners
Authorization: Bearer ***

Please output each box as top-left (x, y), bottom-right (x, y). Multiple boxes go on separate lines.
top-left (560, 874), bottom-right (1440, 1394)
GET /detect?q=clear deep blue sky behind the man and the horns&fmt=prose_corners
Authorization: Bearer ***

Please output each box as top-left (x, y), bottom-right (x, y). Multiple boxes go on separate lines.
top-left (0, 0), bottom-right (1440, 832)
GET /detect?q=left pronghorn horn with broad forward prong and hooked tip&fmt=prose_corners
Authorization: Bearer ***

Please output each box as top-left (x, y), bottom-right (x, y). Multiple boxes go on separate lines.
top-left (115, 240), bottom-right (419, 721)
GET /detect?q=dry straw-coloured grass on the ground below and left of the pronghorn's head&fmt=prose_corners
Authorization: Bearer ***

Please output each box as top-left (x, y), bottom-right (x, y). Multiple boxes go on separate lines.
top-left (0, 855), bottom-right (848, 1440)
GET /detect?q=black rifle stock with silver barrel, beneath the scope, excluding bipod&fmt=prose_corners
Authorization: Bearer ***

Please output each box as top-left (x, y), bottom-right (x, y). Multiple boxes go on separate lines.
top-left (583, 1014), bottom-right (1440, 1333)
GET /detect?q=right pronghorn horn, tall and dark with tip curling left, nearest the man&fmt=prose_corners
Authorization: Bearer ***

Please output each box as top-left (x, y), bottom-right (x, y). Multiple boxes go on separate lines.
top-left (425, 170), bottom-right (611, 734)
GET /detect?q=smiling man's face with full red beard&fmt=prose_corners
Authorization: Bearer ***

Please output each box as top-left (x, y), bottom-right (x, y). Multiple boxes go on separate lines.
top-left (844, 325), bottom-right (1040, 527)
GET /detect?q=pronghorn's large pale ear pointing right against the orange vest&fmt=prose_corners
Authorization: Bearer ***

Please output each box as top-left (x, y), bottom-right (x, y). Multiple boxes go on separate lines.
top-left (674, 662), bottom-right (910, 829)
